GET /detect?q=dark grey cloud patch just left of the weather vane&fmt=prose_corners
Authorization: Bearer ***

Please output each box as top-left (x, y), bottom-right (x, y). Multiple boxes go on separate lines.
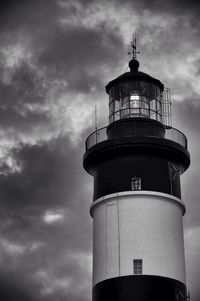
top-left (38, 23), bottom-right (123, 92)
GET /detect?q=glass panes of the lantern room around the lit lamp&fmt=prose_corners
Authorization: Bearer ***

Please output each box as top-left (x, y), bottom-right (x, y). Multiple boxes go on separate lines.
top-left (109, 80), bottom-right (162, 123)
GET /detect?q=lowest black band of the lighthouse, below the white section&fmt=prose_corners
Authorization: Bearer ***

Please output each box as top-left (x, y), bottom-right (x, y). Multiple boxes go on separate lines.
top-left (93, 275), bottom-right (186, 301)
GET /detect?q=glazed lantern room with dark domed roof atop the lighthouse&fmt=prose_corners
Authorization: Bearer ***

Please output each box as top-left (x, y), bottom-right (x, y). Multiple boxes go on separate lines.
top-left (106, 59), bottom-right (171, 125)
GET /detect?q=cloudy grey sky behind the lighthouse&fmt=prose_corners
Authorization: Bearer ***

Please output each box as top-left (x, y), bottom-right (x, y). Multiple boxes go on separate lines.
top-left (0, 0), bottom-right (200, 301)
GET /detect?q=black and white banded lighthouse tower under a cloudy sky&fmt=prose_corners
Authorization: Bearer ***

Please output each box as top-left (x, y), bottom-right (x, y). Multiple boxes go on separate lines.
top-left (83, 40), bottom-right (190, 301)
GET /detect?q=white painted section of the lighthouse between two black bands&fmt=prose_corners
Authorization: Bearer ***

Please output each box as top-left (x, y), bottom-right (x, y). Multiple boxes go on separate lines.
top-left (91, 191), bottom-right (185, 285)
